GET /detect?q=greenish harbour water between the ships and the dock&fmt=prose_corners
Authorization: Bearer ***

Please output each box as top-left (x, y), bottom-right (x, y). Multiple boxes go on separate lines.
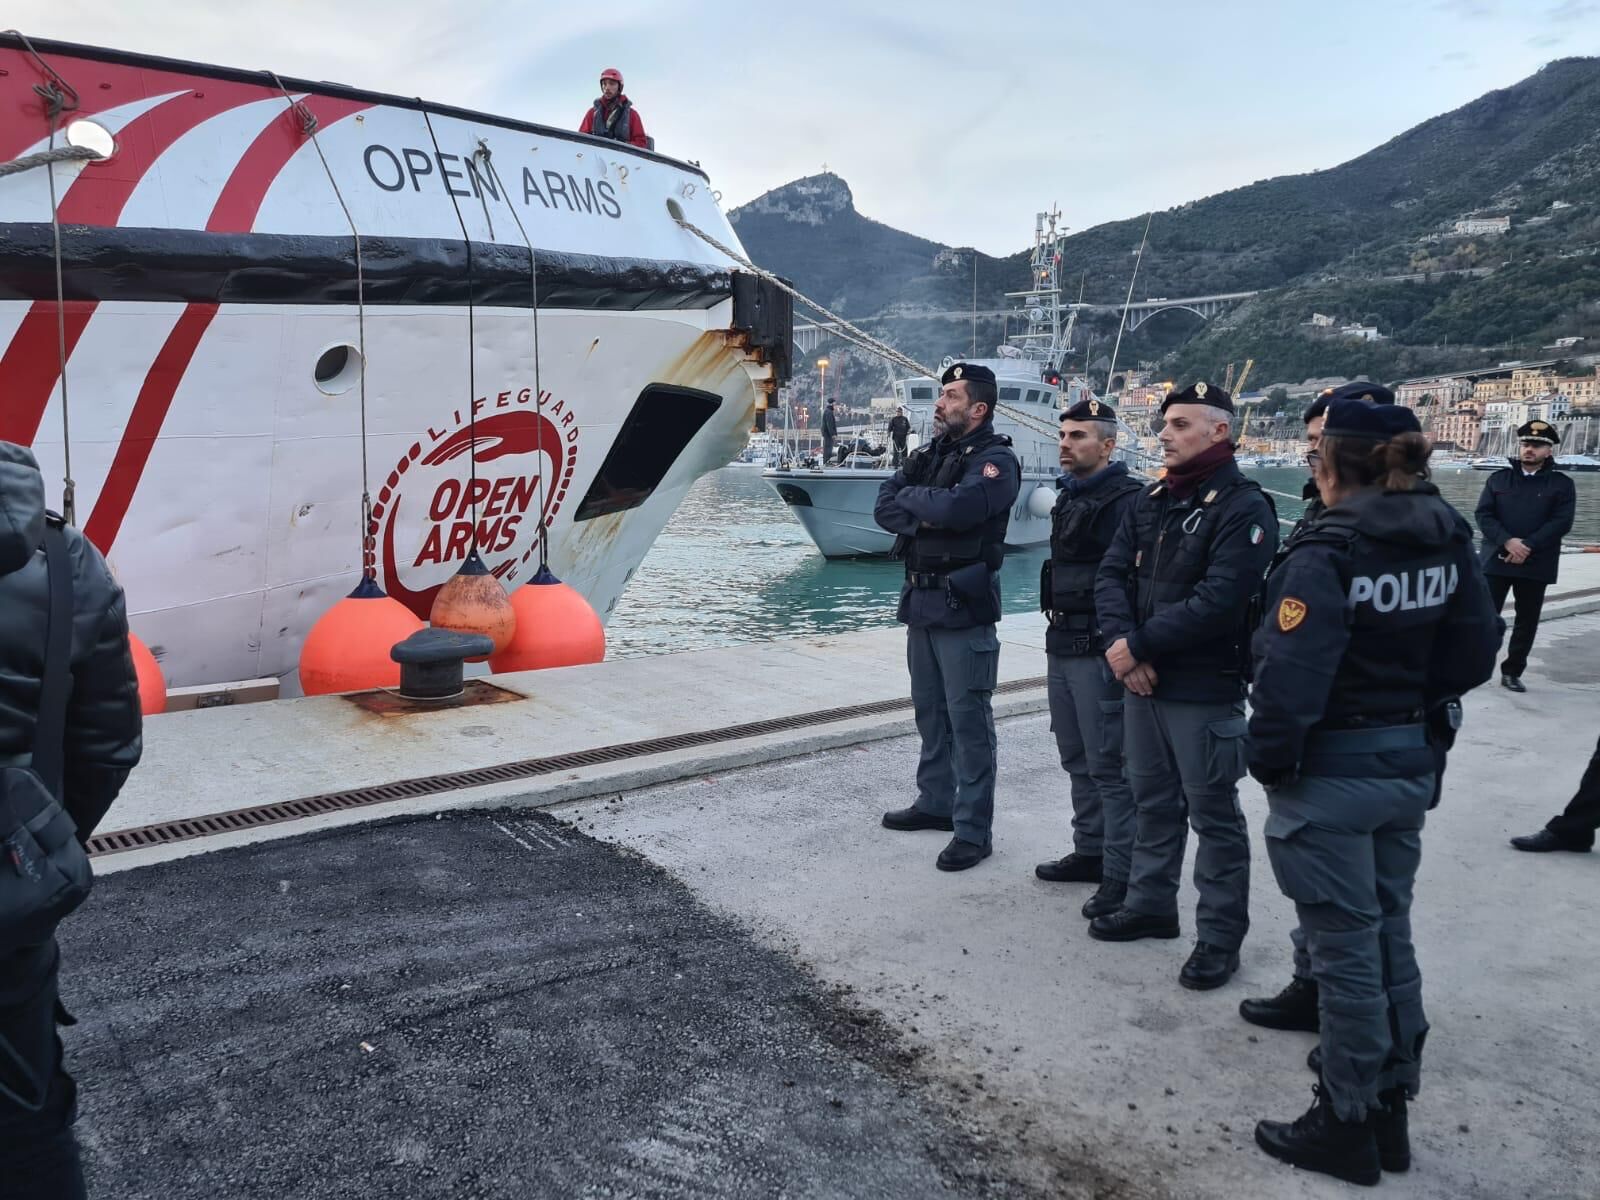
top-left (606, 467), bottom-right (1600, 658)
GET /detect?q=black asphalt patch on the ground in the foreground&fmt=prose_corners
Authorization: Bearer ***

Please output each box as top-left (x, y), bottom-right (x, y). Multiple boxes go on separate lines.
top-left (62, 811), bottom-right (1029, 1200)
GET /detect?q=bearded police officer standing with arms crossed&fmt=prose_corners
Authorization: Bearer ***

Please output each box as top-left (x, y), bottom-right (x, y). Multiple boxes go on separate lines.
top-left (874, 363), bottom-right (1022, 870)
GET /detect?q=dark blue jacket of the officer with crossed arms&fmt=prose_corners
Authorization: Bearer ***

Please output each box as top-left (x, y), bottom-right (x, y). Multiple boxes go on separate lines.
top-left (872, 422), bottom-right (1022, 629)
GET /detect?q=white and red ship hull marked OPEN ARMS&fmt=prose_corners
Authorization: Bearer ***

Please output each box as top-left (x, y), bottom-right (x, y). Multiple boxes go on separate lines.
top-left (0, 35), bottom-right (792, 685)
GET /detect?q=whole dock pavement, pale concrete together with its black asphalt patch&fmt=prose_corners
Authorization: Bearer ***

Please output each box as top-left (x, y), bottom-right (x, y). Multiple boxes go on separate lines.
top-left (62, 555), bottom-right (1600, 1200)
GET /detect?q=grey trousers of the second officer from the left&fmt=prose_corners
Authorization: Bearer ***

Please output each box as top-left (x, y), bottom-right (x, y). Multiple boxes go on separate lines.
top-left (1045, 653), bottom-right (1133, 883)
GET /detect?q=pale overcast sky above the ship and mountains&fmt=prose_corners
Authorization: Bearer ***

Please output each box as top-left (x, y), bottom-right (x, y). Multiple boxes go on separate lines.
top-left (12, 0), bottom-right (1600, 254)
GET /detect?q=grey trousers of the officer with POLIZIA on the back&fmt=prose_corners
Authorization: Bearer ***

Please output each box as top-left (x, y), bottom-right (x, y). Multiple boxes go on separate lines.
top-left (1266, 725), bottom-right (1434, 1120)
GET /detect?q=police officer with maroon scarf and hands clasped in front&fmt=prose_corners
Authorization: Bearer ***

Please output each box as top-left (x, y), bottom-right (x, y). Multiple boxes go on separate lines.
top-left (1090, 382), bottom-right (1278, 989)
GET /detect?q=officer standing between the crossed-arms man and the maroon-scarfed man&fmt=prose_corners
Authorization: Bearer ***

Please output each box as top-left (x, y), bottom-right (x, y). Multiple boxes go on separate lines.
top-left (1034, 398), bottom-right (1147, 918)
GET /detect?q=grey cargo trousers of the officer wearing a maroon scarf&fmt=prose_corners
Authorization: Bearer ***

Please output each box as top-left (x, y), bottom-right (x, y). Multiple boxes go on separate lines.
top-left (1123, 691), bottom-right (1250, 950)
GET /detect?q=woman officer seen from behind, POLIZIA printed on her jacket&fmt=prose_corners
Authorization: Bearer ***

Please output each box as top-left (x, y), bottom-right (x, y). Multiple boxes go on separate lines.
top-left (1250, 398), bottom-right (1499, 1184)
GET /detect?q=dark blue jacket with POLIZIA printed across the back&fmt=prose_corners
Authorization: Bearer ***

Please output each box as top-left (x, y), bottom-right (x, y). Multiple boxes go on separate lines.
top-left (1250, 483), bottom-right (1501, 778)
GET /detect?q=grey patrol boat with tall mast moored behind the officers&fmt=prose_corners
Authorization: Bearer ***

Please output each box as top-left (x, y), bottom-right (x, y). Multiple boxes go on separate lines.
top-left (762, 213), bottom-right (1139, 558)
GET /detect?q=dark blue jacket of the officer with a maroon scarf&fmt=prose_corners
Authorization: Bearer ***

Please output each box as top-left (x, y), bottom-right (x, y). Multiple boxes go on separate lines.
top-left (1094, 461), bottom-right (1278, 701)
